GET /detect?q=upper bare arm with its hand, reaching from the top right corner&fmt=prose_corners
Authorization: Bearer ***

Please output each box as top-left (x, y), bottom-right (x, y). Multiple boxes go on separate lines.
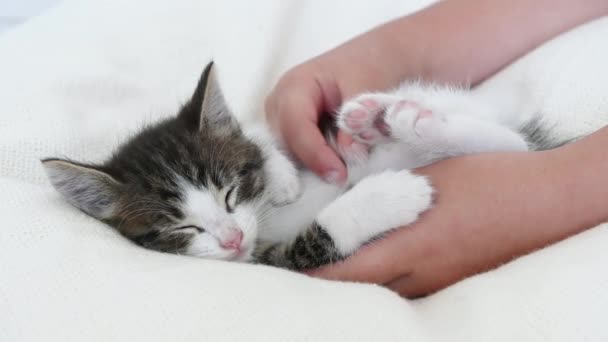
top-left (266, 0), bottom-right (608, 181)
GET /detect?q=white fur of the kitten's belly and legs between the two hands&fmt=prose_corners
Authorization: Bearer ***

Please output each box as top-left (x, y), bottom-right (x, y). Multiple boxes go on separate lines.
top-left (252, 83), bottom-right (527, 255)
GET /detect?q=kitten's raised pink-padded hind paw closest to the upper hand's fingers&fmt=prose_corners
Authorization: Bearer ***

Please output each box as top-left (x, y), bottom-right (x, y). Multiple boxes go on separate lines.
top-left (338, 94), bottom-right (399, 145)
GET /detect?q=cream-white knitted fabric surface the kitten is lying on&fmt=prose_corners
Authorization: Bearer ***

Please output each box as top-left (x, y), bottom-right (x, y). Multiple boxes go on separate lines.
top-left (0, 0), bottom-right (608, 341)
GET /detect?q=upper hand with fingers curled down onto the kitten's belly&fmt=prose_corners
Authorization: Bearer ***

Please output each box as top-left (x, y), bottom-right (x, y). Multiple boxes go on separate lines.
top-left (265, 19), bottom-right (418, 183)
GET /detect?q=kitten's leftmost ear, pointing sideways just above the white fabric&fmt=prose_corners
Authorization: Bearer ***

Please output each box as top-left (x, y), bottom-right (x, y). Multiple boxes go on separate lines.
top-left (42, 159), bottom-right (121, 220)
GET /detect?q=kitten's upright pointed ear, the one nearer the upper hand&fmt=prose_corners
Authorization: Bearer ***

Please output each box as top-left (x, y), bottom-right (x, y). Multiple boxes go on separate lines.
top-left (180, 62), bottom-right (239, 134)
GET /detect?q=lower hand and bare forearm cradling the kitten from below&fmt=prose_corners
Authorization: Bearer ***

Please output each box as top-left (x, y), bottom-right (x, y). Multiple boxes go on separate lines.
top-left (309, 143), bottom-right (608, 297)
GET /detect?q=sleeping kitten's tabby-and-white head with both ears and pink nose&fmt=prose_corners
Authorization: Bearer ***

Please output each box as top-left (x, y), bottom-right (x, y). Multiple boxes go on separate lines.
top-left (43, 63), bottom-right (265, 260)
